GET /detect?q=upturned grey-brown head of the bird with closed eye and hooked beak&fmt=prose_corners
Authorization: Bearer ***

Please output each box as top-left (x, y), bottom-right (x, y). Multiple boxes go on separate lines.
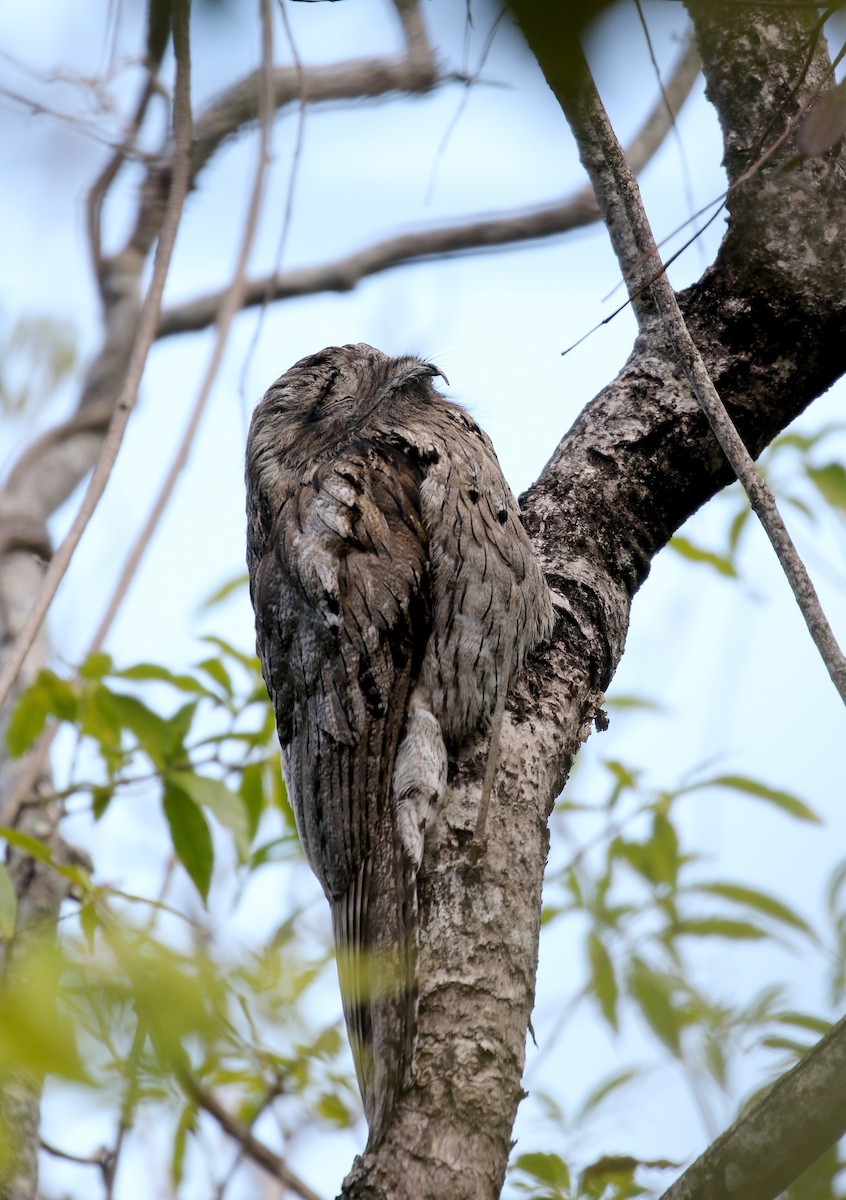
top-left (247, 342), bottom-right (446, 468)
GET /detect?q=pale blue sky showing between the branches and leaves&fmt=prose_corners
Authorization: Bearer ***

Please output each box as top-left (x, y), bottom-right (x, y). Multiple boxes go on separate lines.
top-left (0, 0), bottom-right (846, 1198)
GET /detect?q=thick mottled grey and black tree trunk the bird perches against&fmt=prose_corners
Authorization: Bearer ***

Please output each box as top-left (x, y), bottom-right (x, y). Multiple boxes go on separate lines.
top-left (344, 7), bottom-right (846, 1198)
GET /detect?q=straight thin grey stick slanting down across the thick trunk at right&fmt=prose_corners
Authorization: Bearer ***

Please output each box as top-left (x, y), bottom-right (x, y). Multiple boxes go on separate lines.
top-left (558, 46), bottom-right (846, 703)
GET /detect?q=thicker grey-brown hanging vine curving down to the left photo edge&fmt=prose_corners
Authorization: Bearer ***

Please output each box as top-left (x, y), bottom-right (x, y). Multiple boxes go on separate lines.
top-left (0, 0), bottom-right (192, 704)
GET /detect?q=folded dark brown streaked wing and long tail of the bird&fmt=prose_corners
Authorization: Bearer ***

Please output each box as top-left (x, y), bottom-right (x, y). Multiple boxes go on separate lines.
top-left (248, 442), bottom-right (430, 1140)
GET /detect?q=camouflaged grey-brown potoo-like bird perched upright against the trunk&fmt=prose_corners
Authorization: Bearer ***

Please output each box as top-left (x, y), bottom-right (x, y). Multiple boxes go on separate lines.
top-left (246, 343), bottom-right (553, 1147)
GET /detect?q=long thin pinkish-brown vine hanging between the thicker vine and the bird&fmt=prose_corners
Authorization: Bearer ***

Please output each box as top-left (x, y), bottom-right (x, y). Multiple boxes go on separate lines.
top-left (88, 0), bottom-right (274, 654)
